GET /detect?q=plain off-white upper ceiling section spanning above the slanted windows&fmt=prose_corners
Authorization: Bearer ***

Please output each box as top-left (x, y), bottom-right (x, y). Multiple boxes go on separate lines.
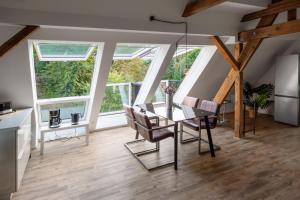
top-left (0, 0), bottom-right (269, 36)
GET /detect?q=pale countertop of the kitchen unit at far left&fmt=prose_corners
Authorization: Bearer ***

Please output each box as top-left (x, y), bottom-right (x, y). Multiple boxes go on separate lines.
top-left (0, 108), bottom-right (32, 130)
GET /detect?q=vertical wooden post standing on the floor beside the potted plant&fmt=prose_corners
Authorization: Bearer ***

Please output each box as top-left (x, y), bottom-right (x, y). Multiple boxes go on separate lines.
top-left (234, 42), bottom-right (244, 137)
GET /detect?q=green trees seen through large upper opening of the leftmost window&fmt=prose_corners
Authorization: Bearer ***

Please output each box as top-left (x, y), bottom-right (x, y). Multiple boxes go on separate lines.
top-left (34, 44), bottom-right (97, 99)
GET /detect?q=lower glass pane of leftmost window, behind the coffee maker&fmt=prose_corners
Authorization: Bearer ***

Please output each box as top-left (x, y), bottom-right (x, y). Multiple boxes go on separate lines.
top-left (40, 101), bottom-right (86, 122)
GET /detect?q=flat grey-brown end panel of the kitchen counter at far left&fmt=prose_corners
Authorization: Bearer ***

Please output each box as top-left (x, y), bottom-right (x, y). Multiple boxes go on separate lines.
top-left (0, 131), bottom-right (16, 194)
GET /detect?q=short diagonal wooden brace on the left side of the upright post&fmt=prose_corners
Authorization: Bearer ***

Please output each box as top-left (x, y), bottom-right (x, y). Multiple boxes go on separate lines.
top-left (211, 36), bottom-right (240, 71)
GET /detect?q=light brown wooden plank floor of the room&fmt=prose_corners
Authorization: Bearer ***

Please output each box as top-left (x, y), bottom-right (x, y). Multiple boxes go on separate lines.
top-left (13, 116), bottom-right (300, 200)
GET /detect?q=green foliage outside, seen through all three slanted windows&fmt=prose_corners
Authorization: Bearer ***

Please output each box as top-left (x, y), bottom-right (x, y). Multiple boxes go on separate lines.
top-left (34, 45), bottom-right (200, 113)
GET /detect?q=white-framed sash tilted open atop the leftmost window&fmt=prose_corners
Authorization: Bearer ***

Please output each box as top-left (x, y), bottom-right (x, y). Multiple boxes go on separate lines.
top-left (34, 42), bottom-right (95, 61)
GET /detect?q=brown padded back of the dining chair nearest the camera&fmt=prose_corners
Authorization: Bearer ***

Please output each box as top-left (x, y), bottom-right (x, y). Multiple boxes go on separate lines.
top-left (133, 111), bottom-right (153, 142)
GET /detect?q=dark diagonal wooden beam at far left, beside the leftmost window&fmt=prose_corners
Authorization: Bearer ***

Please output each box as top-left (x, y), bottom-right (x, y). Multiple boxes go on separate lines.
top-left (0, 26), bottom-right (38, 57)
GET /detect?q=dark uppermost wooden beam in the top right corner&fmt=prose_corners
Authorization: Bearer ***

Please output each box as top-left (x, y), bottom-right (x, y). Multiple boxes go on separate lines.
top-left (241, 0), bottom-right (300, 22)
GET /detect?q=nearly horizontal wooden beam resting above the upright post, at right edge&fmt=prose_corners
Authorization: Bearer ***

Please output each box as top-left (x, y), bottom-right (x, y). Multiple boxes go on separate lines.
top-left (239, 20), bottom-right (300, 41)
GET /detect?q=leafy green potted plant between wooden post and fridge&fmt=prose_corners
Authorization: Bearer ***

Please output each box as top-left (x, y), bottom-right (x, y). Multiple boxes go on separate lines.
top-left (244, 82), bottom-right (274, 118)
